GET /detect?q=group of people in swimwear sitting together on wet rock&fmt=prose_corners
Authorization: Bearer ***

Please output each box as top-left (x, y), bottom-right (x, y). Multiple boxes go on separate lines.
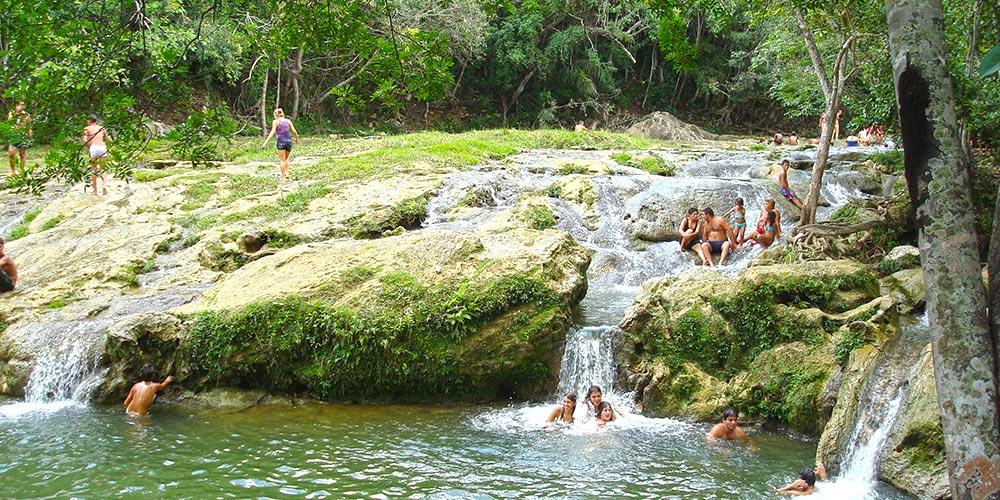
top-left (678, 191), bottom-right (784, 267)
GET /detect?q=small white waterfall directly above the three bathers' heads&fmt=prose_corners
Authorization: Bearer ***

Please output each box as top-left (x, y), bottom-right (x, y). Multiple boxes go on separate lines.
top-left (559, 326), bottom-right (618, 399)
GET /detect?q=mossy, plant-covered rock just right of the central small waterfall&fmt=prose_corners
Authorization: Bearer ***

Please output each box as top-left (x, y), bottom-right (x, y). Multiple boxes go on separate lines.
top-left (620, 261), bottom-right (891, 434)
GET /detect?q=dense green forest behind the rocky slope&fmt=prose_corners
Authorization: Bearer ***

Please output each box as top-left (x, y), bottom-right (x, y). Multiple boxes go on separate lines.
top-left (0, 0), bottom-right (1000, 181)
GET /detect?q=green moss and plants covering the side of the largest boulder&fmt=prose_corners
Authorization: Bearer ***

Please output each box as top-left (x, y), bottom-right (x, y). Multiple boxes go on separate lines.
top-left (189, 273), bottom-right (558, 399)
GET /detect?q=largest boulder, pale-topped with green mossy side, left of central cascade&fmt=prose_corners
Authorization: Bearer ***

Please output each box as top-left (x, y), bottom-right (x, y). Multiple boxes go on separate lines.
top-left (101, 229), bottom-right (590, 400)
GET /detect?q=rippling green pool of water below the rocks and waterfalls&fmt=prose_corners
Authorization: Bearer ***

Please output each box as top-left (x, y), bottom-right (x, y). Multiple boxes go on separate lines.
top-left (0, 401), bottom-right (828, 498)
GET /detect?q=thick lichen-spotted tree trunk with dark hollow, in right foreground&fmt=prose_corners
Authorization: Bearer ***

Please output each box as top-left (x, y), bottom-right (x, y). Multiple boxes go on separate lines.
top-left (885, 0), bottom-right (1000, 499)
